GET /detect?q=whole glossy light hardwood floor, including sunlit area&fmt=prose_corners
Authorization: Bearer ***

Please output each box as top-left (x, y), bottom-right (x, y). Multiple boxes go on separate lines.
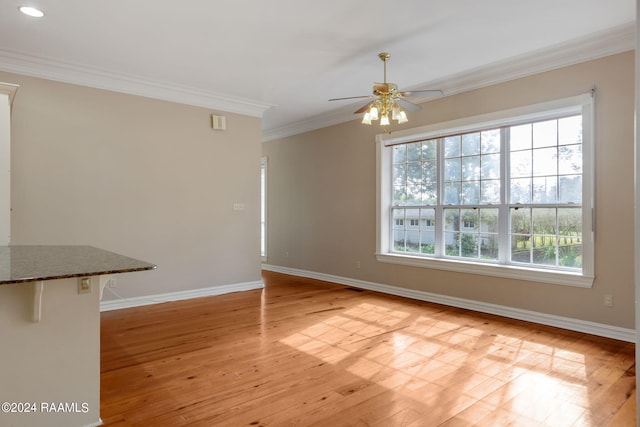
top-left (101, 272), bottom-right (636, 427)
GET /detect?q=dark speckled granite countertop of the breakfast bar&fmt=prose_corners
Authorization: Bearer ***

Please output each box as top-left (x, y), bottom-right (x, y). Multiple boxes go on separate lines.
top-left (0, 246), bottom-right (156, 285)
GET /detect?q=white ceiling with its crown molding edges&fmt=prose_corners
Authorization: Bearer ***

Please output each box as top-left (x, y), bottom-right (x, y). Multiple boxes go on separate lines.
top-left (0, 0), bottom-right (635, 139)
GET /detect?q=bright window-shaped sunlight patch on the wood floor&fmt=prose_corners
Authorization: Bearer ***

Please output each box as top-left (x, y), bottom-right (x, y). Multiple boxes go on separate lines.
top-left (281, 303), bottom-right (606, 426)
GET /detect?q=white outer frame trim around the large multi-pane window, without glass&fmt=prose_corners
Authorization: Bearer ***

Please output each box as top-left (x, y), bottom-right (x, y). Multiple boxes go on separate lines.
top-left (376, 92), bottom-right (595, 288)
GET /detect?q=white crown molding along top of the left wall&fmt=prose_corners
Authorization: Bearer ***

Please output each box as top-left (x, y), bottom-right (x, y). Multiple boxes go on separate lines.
top-left (0, 49), bottom-right (273, 118)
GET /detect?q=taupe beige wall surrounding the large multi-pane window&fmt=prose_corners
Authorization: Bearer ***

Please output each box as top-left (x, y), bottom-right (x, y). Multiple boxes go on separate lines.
top-left (262, 52), bottom-right (634, 328)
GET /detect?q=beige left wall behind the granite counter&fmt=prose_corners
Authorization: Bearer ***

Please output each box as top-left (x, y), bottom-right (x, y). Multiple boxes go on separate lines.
top-left (0, 73), bottom-right (261, 299)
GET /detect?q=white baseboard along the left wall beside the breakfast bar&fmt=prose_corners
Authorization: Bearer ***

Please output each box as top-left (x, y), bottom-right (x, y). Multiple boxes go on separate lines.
top-left (100, 280), bottom-right (264, 311)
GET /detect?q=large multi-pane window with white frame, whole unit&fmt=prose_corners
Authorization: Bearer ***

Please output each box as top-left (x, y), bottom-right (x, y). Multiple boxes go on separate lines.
top-left (377, 94), bottom-right (593, 287)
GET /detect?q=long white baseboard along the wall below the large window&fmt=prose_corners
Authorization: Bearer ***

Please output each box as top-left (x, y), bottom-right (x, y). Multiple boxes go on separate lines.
top-left (262, 264), bottom-right (636, 342)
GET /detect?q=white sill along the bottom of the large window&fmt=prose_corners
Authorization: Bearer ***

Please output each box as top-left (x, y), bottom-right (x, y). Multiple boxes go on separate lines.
top-left (376, 253), bottom-right (594, 288)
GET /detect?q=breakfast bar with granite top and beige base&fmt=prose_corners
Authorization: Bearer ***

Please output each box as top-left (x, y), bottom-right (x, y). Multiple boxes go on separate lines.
top-left (0, 246), bottom-right (155, 427)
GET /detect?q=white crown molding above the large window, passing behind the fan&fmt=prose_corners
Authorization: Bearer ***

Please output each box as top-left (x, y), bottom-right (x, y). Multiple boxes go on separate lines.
top-left (262, 21), bottom-right (636, 142)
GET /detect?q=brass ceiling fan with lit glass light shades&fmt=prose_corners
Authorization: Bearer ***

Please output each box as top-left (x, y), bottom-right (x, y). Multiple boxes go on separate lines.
top-left (329, 52), bottom-right (443, 126)
